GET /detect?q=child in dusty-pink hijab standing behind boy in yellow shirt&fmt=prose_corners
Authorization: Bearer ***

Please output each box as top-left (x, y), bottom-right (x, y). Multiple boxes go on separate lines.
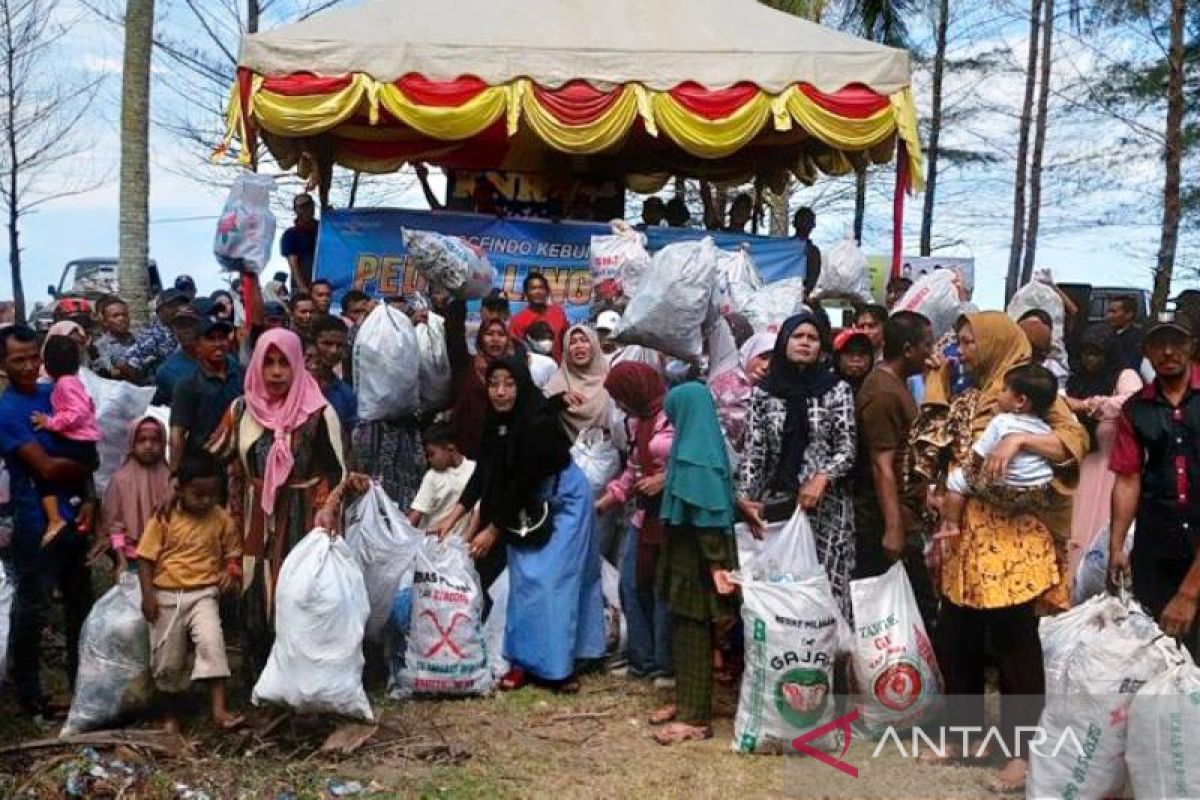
top-left (96, 416), bottom-right (170, 575)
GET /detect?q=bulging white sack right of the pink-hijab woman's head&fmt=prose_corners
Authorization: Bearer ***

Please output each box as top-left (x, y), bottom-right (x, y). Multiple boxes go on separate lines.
top-left (354, 302), bottom-right (421, 422)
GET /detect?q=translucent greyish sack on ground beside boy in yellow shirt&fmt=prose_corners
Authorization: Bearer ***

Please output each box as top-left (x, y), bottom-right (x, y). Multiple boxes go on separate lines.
top-left (59, 572), bottom-right (154, 736)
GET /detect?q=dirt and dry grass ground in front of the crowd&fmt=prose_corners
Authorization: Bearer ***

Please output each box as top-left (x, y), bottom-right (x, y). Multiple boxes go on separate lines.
top-left (0, 675), bottom-right (1017, 800)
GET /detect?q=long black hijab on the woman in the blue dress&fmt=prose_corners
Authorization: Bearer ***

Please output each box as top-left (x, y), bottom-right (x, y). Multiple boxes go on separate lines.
top-left (479, 356), bottom-right (571, 525)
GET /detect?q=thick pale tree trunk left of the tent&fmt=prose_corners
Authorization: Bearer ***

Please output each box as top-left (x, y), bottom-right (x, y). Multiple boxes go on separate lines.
top-left (118, 0), bottom-right (154, 324)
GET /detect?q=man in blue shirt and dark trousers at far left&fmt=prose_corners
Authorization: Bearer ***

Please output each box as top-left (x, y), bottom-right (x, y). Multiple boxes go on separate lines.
top-left (0, 325), bottom-right (92, 717)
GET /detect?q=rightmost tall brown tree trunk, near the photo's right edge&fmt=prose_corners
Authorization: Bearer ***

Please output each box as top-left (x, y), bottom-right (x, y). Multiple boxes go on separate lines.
top-left (1150, 0), bottom-right (1187, 317)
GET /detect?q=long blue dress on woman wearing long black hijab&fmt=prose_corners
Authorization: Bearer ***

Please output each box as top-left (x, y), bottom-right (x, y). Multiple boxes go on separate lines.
top-left (504, 463), bottom-right (605, 680)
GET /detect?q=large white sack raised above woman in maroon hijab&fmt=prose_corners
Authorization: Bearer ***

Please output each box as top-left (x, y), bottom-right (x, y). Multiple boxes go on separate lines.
top-left (613, 236), bottom-right (716, 363)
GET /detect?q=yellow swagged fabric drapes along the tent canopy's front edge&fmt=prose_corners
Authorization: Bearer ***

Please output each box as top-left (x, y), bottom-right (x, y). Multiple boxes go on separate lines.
top-left (231, 74), bottom-right (924, 185)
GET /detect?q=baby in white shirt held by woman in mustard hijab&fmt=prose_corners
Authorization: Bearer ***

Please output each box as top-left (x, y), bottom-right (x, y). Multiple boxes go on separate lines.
top-left (936, 363), bottom-right (1058, 539)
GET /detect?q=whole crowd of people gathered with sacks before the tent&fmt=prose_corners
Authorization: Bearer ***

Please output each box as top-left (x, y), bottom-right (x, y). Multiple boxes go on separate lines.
top-left (0, 199), bottom-right (1200, 788)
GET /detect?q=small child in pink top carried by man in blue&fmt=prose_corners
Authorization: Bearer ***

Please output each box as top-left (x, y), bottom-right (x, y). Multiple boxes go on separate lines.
top-left (31, 336), bottom-right (101, 547)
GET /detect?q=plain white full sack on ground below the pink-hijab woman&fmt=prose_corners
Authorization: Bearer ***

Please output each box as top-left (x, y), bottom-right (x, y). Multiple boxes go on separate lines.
top-left (251, 528), bottom-right (373, 722)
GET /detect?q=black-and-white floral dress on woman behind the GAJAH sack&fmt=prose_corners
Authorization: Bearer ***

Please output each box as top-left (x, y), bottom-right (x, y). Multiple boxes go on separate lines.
top-left (734, 380), bottom-right (858, 621)
